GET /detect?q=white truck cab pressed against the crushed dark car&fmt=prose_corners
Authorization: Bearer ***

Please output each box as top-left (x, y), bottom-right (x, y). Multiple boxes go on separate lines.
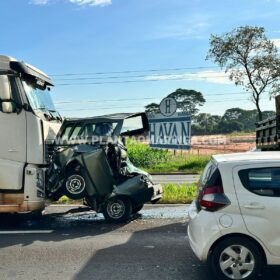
top-left (0, 55), bottom-right (62, 213)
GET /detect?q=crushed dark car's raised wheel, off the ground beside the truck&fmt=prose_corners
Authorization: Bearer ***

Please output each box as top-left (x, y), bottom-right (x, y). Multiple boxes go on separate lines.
top-left (63, 172), bottom-right (86, 200)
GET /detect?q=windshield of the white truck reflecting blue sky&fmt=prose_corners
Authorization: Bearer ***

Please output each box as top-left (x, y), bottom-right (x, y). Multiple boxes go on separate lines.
top-left (23, 82), bottom-right (56, 111)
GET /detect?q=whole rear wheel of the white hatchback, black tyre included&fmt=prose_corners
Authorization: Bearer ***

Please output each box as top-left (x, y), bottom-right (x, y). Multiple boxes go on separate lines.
top-left (208, 237), bottom-right (262, 280)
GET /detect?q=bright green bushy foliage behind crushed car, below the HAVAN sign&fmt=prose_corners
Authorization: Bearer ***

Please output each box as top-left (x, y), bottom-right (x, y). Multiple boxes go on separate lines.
top-left (126, 139), bottom-right (169, 168)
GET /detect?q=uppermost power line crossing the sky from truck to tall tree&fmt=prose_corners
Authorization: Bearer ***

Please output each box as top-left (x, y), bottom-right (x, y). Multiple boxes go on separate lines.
top-left (50, 65), bottom-right (220, 77)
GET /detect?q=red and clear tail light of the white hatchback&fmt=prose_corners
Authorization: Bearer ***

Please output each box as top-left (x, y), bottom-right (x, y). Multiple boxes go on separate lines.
top-left (198, 186), bottom-right (230, 211)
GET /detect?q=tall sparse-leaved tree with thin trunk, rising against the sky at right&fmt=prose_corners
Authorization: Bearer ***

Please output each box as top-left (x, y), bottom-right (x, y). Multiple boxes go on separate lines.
top-left (206, 26), bottom-right (280, 120)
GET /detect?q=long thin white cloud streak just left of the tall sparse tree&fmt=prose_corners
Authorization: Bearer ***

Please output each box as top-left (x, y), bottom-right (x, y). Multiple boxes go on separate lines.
top-left (144, 71), bottom-right (233, 84)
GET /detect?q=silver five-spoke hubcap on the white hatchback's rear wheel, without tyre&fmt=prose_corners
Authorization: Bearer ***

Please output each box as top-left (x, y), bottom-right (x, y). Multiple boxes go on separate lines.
top-left (220, 245), bottom-right (255, 279)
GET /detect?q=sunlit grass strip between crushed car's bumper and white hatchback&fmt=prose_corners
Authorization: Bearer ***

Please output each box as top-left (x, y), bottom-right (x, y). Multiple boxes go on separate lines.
top-left (158, 184), bottom-right (197, 204)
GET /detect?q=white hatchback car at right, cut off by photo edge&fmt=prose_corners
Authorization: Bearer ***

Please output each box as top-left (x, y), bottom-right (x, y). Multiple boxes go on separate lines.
top-left (188, 152), bottom-right (280, 279)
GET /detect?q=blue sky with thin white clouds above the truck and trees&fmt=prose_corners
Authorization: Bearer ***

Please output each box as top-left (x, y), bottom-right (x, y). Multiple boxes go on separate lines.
top-left (0, 0), bottom-right (280, 117)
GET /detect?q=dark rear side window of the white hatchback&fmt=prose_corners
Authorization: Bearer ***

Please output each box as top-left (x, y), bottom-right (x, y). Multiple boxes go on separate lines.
top-left (239, 167), bottom-right (280, 197)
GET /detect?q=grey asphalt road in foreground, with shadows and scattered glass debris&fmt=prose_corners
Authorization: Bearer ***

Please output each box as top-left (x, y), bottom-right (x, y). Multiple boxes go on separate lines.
top-left (0, 206), bottom-right (280, 280)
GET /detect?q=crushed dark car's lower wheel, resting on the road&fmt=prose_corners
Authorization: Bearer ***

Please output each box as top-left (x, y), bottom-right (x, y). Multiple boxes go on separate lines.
top-left (103, 197), bottom-right (132, 222)
